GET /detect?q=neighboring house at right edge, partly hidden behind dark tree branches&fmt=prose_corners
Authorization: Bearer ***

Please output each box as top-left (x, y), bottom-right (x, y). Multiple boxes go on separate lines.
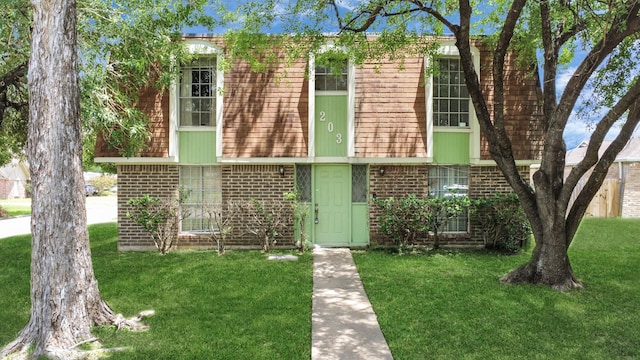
top-left (565, 137), bottom-right (640, 218)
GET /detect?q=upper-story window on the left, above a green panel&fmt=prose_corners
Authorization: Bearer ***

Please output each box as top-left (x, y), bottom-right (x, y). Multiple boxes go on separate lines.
top-left (178, 56), bottom-right (217, 126)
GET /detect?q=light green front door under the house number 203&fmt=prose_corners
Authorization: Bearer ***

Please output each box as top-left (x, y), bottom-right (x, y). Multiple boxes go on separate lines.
top-left (313, 164), bottom-right (351, 246)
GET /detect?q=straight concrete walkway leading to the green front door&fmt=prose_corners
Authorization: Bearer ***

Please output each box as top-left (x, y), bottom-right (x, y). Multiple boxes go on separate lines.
top-left (311, 248), bottom-right (393, 360)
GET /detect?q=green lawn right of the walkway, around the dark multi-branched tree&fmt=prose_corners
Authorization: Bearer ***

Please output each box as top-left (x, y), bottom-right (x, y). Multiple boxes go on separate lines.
top-left (354, 219), bottom-right (640, 359)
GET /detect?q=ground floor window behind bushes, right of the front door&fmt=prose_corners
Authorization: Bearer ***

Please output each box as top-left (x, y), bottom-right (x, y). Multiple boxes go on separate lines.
top-left (429, 165), bottom-right (469, 232)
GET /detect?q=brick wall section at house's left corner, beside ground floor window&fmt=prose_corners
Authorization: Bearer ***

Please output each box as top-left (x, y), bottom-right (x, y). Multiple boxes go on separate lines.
top-left (118, 165), bottom-right (180, 250)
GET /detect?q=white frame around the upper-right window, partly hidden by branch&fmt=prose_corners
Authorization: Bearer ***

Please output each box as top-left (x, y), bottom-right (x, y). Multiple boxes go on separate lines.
top-left (424, 41), bottom-right (480, 164)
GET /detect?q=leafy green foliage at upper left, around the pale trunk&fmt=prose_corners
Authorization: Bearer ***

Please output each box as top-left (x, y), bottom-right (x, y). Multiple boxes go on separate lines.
top-left (0, 0), bottom-right (219, 164)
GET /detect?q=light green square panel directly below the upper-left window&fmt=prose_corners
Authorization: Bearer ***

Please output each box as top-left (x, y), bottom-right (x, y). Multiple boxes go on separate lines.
top-left (180, 131), bottom-right (217, 164)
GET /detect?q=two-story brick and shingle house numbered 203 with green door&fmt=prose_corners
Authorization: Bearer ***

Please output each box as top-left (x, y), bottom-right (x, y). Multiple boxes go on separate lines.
top-left (96, 36), bottom-right (542, 250)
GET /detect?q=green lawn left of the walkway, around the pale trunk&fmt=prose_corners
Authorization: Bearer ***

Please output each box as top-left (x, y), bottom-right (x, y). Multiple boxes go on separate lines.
top-left (0, 224), bottom-right (312, 359)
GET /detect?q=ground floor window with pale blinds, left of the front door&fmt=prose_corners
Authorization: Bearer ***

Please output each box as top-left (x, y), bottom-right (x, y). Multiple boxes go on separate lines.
top-left (180, 166), bottom-right (222, 232)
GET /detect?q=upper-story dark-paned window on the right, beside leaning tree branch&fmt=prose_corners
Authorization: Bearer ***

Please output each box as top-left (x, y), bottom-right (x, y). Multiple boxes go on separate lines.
top-left (433, 57), bottom-right (470, 127)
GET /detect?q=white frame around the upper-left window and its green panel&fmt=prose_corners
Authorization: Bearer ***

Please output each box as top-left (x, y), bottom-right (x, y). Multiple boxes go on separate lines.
top-left (169, 39), bottom-right (224, 158)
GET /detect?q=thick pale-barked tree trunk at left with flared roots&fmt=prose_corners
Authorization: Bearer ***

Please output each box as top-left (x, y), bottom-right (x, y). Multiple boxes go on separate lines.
top-left (0, 0), bottom-right (114, 357)
